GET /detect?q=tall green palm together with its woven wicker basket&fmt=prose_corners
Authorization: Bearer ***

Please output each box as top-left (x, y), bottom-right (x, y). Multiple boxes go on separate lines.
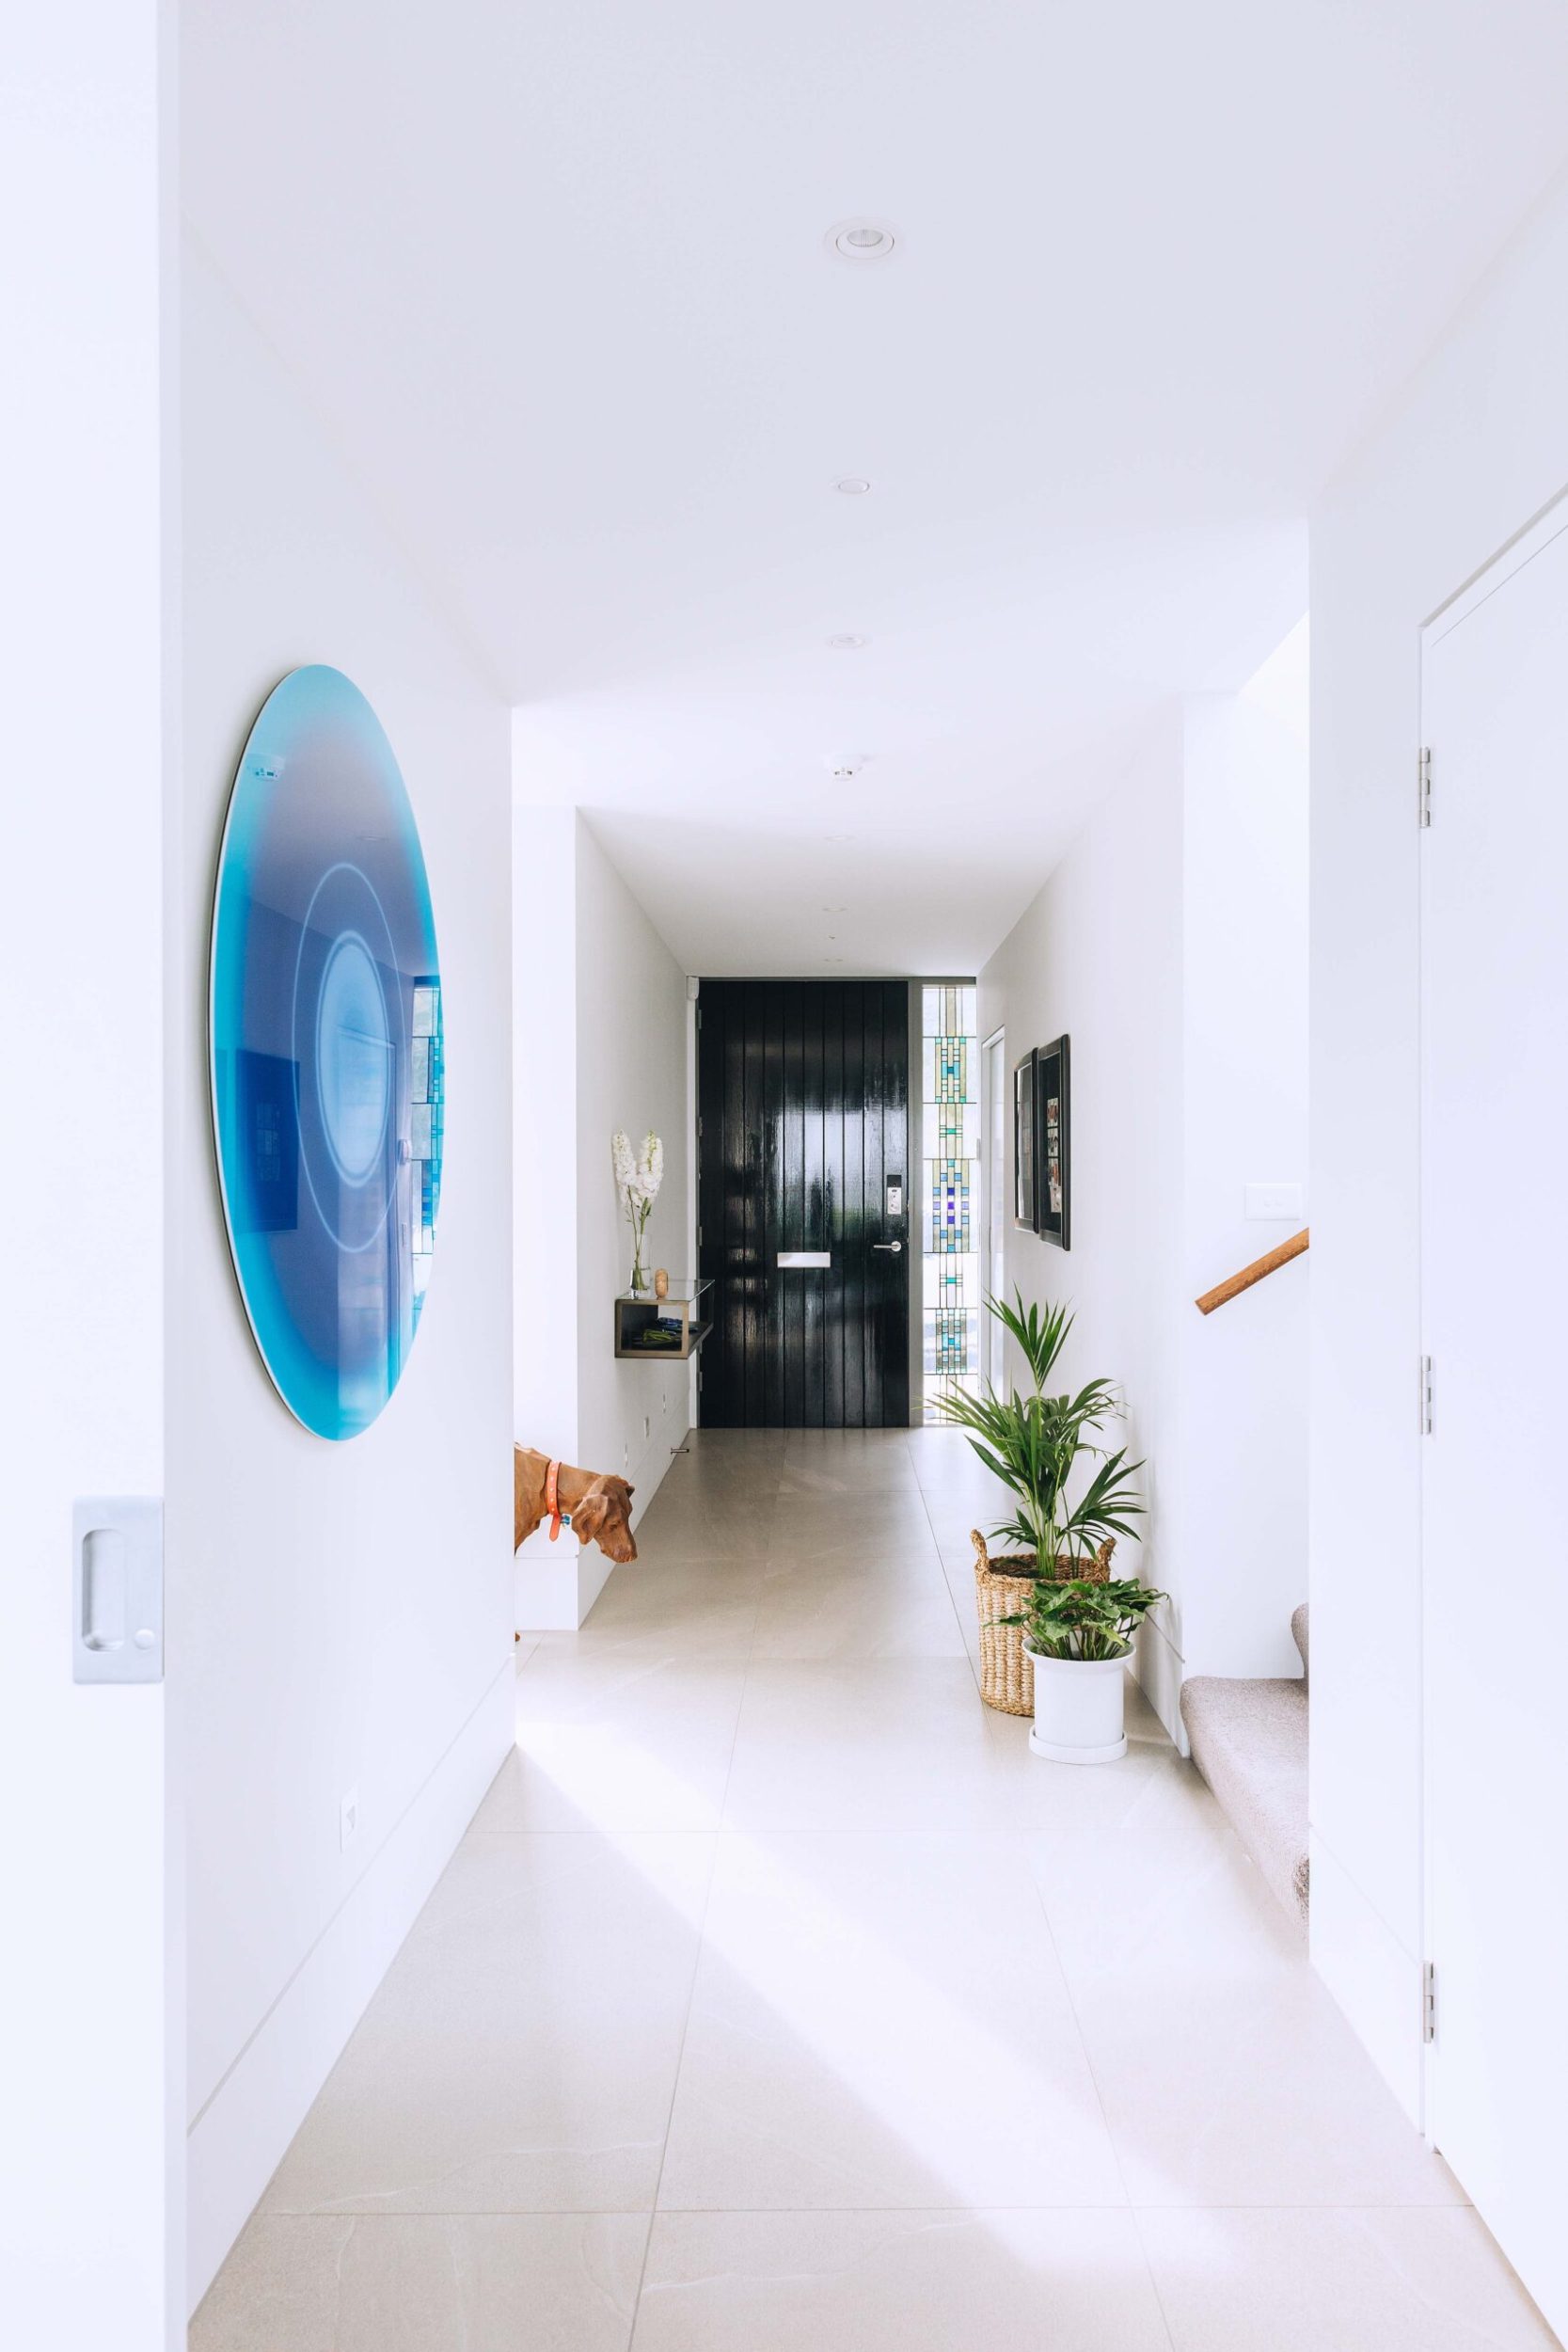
top-left (942, 1292), bottom-right (1143, 1759)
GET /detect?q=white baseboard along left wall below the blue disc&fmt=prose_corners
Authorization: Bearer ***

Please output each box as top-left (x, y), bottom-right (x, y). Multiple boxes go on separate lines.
top-left (188, 1659), bottom-right (515, 2310)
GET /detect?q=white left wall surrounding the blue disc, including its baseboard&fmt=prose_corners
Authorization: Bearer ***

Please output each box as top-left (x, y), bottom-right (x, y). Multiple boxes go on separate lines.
top-left (169, 249), bottom-right (513, 2294)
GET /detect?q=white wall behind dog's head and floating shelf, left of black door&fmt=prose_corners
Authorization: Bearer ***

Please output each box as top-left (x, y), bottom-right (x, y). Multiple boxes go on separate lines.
top-left (513, 800), bottom-right (696, 1628)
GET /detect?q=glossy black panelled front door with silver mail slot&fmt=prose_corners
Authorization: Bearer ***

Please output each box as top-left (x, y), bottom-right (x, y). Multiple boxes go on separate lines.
top-left (698, 981), bottom-right (912, 1430)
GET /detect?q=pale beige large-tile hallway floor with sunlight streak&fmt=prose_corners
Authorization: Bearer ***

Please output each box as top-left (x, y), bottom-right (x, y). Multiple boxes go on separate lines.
top-left (193, 1433), bottom-right (1552, 2352)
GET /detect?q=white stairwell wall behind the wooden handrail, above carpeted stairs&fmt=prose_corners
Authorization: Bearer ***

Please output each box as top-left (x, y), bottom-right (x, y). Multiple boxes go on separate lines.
top-left (1173, 649), bottom-right (1312, 1675)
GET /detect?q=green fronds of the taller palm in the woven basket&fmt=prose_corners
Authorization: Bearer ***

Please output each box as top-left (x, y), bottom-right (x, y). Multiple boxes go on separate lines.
top-left (942, 1292), bottom-right (1143, 1581)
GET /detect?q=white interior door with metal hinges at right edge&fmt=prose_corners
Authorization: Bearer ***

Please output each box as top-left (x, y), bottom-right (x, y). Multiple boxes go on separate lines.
top-left (1419, 496), bottom-right (1568, 2333)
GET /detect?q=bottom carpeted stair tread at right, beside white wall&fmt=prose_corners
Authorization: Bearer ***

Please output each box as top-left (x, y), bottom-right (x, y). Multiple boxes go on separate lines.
top-left (1182, 1665), bottom-right (1307, 1919)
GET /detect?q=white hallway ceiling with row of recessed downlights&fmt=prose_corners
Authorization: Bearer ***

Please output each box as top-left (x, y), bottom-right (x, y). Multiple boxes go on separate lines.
top-left (181, 0), bottom-right (1568, 974)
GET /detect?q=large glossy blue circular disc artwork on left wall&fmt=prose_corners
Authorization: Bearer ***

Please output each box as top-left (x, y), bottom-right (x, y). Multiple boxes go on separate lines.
top-left (212, 668), bottom-right (444, 1438)
